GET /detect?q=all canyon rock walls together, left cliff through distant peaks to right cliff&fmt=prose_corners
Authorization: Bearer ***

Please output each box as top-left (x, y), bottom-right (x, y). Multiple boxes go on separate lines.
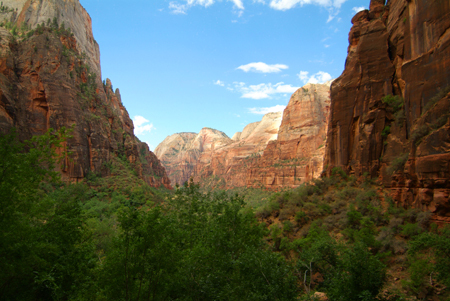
top-left (0, 0), bottom-right (450, 221)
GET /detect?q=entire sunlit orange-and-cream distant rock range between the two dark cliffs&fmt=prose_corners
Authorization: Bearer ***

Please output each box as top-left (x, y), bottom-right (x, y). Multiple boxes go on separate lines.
top-left (155, 83), bottom-right (330, 189)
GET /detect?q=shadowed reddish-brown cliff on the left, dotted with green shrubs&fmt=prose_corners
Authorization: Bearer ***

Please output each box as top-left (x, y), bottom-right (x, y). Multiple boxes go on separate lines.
top-left (0, 0), bottom-right (170, 188)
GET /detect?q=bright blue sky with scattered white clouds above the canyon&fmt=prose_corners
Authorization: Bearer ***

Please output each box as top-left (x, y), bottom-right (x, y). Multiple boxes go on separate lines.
top-left (80, 0), bottom-right (369, 150)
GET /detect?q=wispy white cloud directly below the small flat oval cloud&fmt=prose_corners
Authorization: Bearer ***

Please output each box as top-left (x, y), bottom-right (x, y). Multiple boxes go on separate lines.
top-left (239, 82), bottom-right (300, 99)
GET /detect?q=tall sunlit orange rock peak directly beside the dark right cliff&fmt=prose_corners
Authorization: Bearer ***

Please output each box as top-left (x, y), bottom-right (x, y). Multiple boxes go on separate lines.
top-left (246, 83), bottom-right (330, 189)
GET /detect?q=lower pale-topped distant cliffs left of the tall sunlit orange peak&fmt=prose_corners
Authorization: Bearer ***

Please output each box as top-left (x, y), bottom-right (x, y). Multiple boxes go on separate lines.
top-left (155, 113), bottom-right (281, 187)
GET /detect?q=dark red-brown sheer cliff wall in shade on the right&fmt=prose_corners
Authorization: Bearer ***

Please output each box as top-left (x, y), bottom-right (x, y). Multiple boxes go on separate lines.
top-left (325, 0), bottom-right (450, 216)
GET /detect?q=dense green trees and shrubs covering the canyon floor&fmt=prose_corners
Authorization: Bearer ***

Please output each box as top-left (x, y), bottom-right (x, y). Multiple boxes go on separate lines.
top-left (0, 131), bottom-right (450, 301)
